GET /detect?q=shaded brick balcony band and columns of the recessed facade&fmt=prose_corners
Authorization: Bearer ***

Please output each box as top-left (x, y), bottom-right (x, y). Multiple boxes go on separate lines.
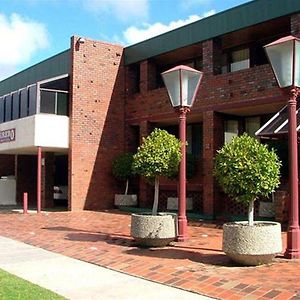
top-left (126, 14), bottom-right (300, 216)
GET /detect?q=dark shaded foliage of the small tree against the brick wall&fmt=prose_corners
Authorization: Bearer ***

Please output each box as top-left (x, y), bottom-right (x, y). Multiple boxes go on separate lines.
top-left (112, 153), bottom-right (133, 180)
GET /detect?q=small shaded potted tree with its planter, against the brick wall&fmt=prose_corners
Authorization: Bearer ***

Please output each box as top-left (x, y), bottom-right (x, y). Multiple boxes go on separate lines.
top-left (112, 153), bottom-right (137, 206)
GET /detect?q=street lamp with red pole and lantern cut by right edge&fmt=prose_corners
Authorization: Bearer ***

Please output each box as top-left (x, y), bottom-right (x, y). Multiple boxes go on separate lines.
top-left (264, 35), bottom-right (300, 258)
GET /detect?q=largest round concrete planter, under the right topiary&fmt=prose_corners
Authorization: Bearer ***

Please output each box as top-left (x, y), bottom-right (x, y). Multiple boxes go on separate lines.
top-left (223, 222), bottom-right (282, 266)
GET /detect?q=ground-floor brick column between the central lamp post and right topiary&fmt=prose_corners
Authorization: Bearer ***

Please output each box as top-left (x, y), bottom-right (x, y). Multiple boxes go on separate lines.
top-left (203, 111), bottom-right (224, 215)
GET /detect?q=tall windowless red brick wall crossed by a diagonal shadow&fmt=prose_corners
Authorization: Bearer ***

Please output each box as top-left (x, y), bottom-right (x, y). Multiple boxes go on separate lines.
top-left (69, 37), bottom-right (124, 210)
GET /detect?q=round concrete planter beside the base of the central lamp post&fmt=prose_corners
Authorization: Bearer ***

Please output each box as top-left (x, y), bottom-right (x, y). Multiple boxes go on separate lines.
top-left (131, 213), bottom-right (177, 247)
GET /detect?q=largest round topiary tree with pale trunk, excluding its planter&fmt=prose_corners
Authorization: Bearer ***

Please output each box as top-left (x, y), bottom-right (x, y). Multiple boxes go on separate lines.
top-left (214, 134), bottom-right (281, 226)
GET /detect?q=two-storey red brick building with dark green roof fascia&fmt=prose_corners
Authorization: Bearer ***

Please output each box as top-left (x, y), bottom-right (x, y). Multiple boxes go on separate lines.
top-left (0, 0), bottom-right (300, 217)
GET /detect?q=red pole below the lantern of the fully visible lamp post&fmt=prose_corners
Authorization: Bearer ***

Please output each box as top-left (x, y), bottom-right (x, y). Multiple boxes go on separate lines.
top-left (177, 107), bottom-right (189, 242)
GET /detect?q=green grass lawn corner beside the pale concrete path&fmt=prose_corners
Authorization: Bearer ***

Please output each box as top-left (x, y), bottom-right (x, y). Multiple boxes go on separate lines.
top-left (0, 269), bottom-right (66, 300)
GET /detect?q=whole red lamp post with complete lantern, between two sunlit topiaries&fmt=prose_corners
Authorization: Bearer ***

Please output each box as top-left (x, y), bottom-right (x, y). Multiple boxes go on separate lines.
top-left (161, 65), bottom-right (203, 242)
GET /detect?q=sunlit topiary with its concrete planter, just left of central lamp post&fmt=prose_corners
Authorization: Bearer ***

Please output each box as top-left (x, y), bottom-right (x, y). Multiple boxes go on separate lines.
top-left (131, 129), bottom-right (181, 247)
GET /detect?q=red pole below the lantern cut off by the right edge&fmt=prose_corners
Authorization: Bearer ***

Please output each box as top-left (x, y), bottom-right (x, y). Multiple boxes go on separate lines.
top-left (285, 88), bottom-right (300, 258)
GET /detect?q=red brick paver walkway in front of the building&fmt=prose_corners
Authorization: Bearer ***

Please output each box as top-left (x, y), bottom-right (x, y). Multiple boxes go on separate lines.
top-left (0, 211), bottom-right (300, 300)
